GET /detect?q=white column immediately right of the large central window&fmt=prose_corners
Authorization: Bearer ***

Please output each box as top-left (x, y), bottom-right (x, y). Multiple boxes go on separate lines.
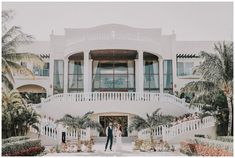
top-left (136, 50), bottom-right (144, 93)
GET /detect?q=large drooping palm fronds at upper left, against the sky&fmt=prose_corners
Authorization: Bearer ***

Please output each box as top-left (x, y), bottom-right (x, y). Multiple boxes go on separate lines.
top-left (2, 10), bottom-right (44, 90)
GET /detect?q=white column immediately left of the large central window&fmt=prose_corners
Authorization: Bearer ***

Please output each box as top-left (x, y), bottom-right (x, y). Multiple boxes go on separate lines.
top-left (83, 50), bottom-right (91, 92)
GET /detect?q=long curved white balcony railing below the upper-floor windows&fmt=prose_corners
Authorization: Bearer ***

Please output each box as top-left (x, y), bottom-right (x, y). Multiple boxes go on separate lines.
top-left (42, 92), bottom-right (185, 107)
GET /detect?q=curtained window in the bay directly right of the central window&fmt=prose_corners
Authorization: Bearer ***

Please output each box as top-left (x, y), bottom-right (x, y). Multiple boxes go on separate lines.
top-left (144, 60), bottom-right (159, 92)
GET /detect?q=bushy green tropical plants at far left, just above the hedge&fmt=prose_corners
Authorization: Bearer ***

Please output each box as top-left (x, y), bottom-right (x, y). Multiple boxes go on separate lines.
top-left (2, 90), bottom-right (40, 138)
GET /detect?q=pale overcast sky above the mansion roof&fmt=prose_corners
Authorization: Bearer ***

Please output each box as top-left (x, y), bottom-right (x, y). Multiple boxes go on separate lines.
top-left (2, 2), bottom-right (233, 40)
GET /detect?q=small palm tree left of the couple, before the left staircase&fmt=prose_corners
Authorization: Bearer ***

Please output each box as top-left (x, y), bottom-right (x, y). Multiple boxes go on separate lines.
top-left (56, 111), bottom-right (102, 152)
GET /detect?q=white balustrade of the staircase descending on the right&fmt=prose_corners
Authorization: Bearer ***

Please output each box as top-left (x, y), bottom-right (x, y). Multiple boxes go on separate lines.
top-left (138, 116), bottom-right (215, 140)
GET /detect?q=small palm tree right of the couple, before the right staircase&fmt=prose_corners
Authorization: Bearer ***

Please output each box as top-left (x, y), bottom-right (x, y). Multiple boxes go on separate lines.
top-left (129, 108), bottom-right (173, 151)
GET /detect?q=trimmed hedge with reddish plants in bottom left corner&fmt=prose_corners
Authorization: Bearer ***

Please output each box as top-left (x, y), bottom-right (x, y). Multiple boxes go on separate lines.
top-left (2, 139), bottom-right (44, 156)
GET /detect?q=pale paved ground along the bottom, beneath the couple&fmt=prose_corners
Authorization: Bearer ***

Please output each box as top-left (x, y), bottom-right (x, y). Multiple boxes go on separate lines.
top-left (46, 143), bottom-right (184, 156)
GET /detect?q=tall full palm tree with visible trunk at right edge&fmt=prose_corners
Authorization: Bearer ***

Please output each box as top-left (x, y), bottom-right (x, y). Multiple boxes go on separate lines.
top-left (182, 42), bottom-right (233, 135)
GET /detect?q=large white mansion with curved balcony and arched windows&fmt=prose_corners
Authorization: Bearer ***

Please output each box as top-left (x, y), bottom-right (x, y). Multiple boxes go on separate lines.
top-left (15, 24), bottom-right (215, 140)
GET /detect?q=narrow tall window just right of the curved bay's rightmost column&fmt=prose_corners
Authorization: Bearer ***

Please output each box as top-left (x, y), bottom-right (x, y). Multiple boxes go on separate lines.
top-left (163, 60), bottom-right (173, 91)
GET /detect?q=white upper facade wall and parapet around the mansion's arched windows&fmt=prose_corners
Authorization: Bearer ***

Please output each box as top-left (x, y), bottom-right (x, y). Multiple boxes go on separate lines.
top-left (13, 24), bottom-right (220, 95)
